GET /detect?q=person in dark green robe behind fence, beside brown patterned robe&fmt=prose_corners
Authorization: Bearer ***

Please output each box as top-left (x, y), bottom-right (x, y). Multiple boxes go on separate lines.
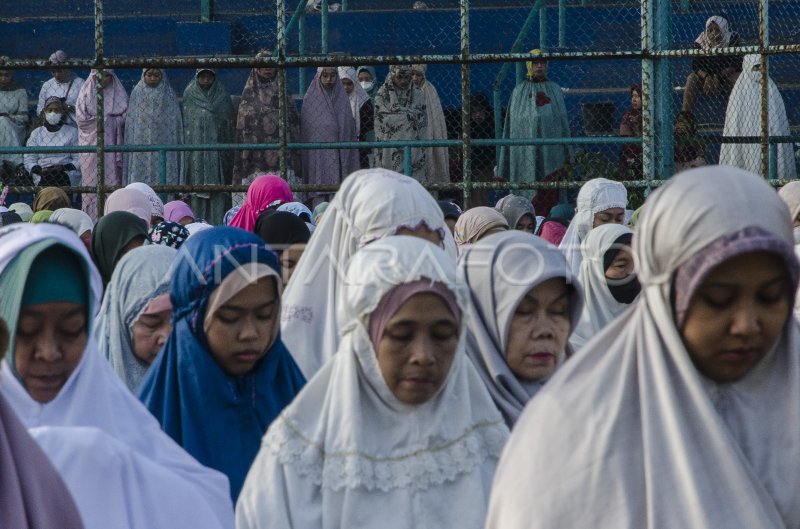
top-left (185, 68), bottom-right (234, 220)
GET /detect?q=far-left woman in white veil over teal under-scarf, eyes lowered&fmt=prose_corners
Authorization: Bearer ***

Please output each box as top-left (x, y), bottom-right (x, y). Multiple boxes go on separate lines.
top-left (0, 223), bottom-right (233, 529)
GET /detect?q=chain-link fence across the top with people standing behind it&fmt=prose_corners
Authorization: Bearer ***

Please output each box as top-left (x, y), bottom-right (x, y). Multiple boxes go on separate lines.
top-left (0, 0), bottom-right (800, 223)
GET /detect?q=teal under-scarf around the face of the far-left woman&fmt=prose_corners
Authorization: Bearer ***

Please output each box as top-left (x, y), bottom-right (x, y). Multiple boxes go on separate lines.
top-left (0, 239), bottom-right (89, 372)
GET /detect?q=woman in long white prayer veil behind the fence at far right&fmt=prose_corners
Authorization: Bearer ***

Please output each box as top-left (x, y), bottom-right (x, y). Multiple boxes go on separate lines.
top-left (719, 54), bottom-right (797, 180)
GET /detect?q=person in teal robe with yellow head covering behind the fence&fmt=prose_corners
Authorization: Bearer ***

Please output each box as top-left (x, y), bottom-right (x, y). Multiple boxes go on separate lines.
top-left (497, 50), bottom-right (572, 198)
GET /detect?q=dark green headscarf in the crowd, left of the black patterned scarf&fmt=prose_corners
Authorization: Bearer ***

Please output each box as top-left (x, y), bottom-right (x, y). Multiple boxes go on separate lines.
top-left (92, 211), bottom-right (147, 285)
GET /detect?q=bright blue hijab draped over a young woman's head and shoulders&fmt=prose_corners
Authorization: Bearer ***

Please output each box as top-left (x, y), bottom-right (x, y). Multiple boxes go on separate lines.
top-left (139, 227), bottom-right (305, 503)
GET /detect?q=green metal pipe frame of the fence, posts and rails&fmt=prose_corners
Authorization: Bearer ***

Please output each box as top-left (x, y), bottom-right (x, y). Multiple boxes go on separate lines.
top-left (0, 0), bottom-right (800, 212)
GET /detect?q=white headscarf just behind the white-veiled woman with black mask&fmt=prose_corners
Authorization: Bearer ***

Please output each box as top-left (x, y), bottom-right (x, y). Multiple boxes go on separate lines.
top-left (558, 178), bottom-right (628, 276)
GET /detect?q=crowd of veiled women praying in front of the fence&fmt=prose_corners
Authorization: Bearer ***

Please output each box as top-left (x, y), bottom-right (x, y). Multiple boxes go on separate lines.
top-left (0, 159), bottom-right (800, 529)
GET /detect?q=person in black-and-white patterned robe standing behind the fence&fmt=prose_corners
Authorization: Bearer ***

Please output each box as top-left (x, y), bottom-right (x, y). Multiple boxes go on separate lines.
top-left (375, 65), bottom-right (428, 183)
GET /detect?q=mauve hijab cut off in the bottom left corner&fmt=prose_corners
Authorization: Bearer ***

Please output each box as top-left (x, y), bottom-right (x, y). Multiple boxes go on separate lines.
top-left (0, 396), bottom-right (83, 529)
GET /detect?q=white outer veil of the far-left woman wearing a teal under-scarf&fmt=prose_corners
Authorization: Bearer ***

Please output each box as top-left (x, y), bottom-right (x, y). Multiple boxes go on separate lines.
top-left (0, 223), bottom-right (232, 527)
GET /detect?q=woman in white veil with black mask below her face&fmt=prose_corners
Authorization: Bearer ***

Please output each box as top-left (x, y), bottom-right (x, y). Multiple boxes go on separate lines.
top-left (569, 224), bottom-right (641, 351)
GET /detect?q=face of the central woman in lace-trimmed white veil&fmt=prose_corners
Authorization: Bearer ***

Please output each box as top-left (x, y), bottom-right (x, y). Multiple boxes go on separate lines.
top-left (376, 293), bottom-right (459, 405)
